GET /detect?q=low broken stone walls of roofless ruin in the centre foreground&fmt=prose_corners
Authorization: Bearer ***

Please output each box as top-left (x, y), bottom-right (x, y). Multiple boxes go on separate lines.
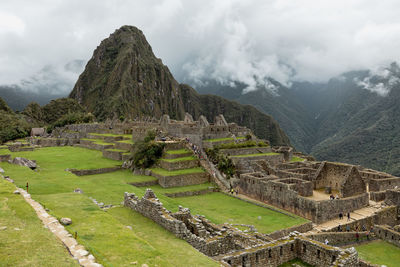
top-left (124, 189), bottom-right (358, 267)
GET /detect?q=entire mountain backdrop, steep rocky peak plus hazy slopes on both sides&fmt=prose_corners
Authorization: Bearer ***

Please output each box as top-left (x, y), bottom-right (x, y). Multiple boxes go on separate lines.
top-left (0, 26), bottom-right (400, 175)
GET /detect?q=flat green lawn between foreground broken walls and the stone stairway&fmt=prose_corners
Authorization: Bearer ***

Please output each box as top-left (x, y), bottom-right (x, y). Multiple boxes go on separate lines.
top-left (173, 193), bottom-right (307, 233)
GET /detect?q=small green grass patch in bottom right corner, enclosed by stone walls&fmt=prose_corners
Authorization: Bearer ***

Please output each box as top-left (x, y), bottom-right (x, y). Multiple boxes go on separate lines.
top-left (355, 240), bottom-right (400, 267)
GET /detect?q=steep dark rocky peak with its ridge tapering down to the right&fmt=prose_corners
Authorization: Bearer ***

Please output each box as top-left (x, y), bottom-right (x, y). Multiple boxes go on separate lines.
top-left (70, 26), bottom-right (290, 145)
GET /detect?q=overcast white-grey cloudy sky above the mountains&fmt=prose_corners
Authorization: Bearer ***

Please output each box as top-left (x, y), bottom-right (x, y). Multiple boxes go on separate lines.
top-left (0, 0), bottom-right (400, 94)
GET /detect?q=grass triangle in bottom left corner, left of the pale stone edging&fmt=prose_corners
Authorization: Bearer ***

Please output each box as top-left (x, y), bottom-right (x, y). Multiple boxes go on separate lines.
top-left (0, 179), bottom-right (79, 266)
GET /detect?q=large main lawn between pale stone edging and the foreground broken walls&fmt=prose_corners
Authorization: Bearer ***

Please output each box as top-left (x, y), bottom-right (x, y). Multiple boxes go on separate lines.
top-left (0, 147), bottom-right (218, 266)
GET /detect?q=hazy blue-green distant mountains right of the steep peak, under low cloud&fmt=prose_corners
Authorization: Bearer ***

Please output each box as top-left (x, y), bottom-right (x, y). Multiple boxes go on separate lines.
top-left (197, 63), bottom-right (400, 175)
